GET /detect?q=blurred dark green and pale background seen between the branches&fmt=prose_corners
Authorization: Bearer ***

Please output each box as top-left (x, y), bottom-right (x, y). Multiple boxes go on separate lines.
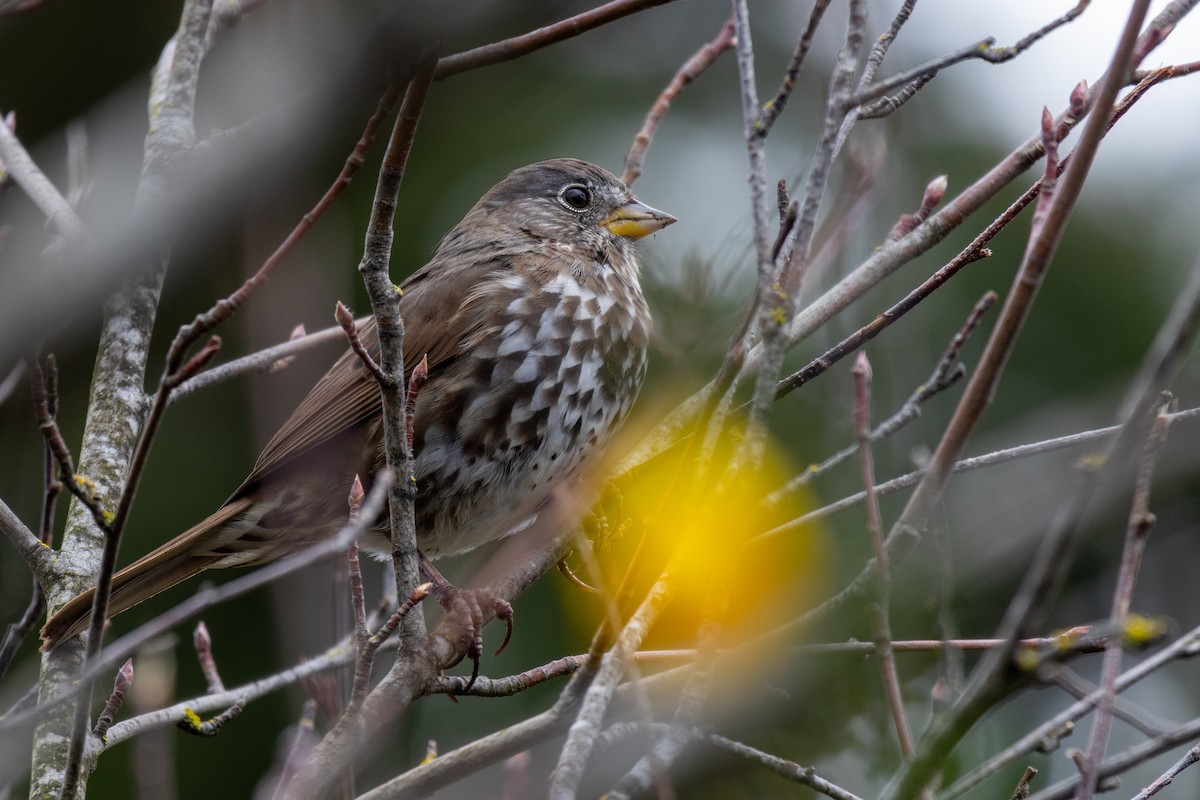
top-left (0, 0), bottom-right (1200, 798)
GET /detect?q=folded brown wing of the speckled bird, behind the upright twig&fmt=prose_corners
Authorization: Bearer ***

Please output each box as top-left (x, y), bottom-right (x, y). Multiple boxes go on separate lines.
top-left (234, 259), bottom-right (503, 497)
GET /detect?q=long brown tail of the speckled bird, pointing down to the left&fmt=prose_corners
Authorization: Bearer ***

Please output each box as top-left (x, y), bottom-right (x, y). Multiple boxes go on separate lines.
top-left (41, 499), bottom-right (250, 652)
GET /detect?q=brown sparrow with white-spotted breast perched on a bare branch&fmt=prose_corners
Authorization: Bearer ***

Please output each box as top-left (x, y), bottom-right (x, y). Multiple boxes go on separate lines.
top-left (42, 158), bottom-right (676, 650)
